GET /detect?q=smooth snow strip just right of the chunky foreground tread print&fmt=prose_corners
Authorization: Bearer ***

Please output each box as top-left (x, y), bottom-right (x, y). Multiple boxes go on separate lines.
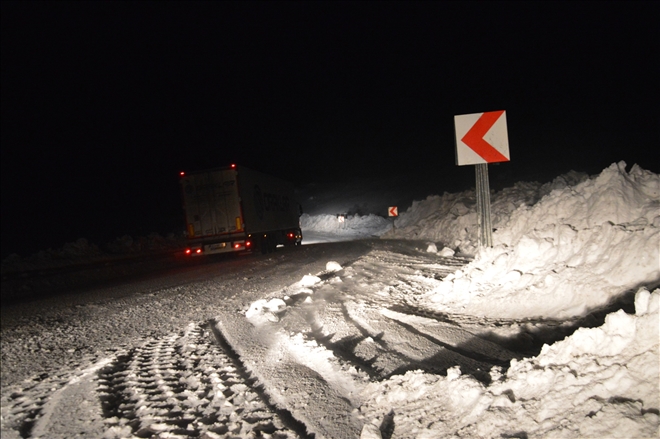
top-left (214, 312), bottom-right (363, 439)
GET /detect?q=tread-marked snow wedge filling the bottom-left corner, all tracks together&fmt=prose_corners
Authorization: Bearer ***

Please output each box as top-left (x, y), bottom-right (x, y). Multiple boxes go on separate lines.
top-left (2, 324), bottom-right (307, 439)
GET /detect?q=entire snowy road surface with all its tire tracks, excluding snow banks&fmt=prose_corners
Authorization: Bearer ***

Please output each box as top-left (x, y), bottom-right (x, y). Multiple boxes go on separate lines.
top-left (1, 240), bottom-right (536, 438)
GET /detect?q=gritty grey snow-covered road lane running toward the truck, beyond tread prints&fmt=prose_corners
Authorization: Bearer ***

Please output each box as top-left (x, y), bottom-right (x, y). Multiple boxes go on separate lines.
top-left (1, 242), bottom-right (369, 437)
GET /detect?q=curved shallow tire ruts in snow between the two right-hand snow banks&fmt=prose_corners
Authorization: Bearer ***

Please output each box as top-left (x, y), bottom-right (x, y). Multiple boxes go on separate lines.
top-left (281, 250), bottom-right (520, 382)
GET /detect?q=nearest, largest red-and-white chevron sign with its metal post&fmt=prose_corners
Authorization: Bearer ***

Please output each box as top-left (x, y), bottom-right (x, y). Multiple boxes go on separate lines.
top-left (454, 111), bottom-right (510, 247)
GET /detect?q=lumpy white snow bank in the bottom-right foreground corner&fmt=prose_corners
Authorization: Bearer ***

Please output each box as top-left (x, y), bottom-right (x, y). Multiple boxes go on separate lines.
top-left (360, 289), bottom-right (660, 438)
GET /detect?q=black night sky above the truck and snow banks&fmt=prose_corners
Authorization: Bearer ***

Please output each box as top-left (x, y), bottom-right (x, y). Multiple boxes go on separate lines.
top-left (0, 1), bottom-right (660, 257)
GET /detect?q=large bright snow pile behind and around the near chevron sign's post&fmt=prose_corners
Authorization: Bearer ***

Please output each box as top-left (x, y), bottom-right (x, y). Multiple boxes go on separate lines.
top-left (385, 162), bottom-right (660, 318)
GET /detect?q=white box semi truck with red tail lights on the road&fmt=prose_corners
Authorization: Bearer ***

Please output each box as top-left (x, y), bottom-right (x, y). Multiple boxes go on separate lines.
top-left (180, 165), bottom-right (302, 256)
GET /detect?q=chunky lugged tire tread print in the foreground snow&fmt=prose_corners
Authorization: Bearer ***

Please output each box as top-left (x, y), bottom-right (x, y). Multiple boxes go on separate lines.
top-left (100, 324), bottom-right (299, 439)
